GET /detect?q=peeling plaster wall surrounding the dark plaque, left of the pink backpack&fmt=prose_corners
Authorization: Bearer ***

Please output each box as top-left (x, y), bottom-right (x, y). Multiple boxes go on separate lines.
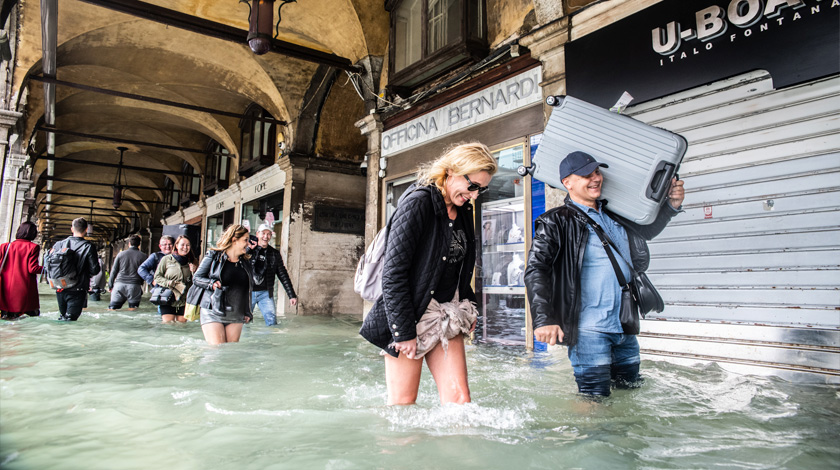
top-left (289, 170), bottom-right (365, 318)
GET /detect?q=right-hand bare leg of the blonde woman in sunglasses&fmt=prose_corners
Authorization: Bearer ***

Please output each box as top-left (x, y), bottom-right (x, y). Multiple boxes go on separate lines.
top-left (426, 335), bottom-right (470, 403)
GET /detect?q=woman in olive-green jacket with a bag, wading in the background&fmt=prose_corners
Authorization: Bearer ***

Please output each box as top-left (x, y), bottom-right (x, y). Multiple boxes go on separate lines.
top-left (154, 235), bottom-right (196, 323)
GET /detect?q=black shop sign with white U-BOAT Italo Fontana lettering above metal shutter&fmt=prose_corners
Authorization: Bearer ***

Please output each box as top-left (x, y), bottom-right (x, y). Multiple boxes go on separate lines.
top-left (565, 0), bottom-right (840, 108)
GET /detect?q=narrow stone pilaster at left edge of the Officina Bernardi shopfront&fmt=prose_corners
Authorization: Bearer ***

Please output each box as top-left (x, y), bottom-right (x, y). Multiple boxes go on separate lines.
top-left (356, 114), bottom-right (384, 315)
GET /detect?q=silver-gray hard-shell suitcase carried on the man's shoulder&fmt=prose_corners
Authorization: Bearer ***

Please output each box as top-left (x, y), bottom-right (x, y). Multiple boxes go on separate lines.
top-left (519, 96), bottom-right (688, 225)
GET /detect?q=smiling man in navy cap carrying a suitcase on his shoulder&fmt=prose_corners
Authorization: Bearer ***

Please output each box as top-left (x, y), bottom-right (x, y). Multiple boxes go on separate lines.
top-left (525, 152), bottom-right (685, 396)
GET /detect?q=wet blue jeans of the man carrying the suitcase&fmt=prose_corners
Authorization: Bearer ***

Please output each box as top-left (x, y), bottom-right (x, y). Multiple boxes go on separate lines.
top-left (569, 330), bottom-right (641, 396)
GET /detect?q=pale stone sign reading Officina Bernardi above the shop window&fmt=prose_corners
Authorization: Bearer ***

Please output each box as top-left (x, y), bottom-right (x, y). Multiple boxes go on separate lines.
top-left (382, 67), bottom-right (542, 157)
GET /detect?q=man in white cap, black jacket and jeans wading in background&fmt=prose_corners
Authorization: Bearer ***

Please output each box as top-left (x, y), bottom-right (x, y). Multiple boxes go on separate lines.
top-left (251, 224), bottom-right (297, 326)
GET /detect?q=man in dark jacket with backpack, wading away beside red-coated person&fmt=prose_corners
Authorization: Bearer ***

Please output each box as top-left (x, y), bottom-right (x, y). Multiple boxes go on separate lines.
top-left (50, 217), bottom-right (99, 321)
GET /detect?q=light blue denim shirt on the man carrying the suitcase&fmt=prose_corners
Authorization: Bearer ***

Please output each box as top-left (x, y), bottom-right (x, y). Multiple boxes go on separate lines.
top-left (572, 201), bottom-right (630, 333)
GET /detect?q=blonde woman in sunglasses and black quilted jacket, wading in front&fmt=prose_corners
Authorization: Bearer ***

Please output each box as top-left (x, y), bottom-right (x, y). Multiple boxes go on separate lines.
top-left (359, 143), bottom-right (497, 405)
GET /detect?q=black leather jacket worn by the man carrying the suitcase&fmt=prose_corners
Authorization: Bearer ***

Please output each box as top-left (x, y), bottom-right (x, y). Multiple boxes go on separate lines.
top-left (525, 196), bottom-right (679, 346)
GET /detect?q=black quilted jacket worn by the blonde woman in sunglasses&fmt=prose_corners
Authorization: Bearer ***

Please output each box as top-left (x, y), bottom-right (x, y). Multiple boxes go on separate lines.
top-left (359, 186), bottom-right (475, 357)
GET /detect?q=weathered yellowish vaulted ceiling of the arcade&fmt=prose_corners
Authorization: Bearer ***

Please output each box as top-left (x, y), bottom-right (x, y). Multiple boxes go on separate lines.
top-left (13, 0), bottom-right (388, 242)
